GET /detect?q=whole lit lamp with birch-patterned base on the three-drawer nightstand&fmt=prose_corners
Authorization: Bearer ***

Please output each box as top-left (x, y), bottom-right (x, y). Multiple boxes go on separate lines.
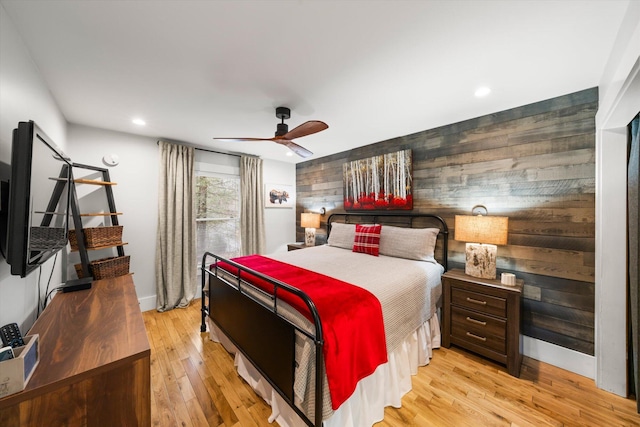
top-left (454, 205), bottom-right (509, 279)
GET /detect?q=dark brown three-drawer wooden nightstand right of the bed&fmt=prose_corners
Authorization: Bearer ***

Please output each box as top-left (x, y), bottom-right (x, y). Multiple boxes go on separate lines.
top-left (442, 270), bottom-right (524, 377)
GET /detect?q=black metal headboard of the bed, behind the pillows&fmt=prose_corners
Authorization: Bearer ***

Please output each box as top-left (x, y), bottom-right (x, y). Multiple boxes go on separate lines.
top-left (327, 212), bottom-right (449, 271)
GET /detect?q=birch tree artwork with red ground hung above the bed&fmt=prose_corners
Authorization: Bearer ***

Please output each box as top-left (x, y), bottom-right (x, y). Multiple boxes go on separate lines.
top-left (342, 150), bottom-right (413, 211)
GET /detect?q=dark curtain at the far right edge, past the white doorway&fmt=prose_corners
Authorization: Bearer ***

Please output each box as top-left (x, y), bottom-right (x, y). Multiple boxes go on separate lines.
top-left (627, 114), bottom-right (640, 413)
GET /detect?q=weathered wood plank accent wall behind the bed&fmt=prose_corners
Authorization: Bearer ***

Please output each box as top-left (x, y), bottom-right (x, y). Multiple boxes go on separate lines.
top-left (296, 88), bottom-right (598, 355)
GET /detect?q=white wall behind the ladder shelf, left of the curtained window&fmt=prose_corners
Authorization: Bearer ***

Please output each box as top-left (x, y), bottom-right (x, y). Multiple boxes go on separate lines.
top-left (67, 124), bottom-right (159, 310)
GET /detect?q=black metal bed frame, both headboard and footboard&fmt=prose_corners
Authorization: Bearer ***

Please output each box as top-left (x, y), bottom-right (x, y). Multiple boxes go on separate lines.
top-left (200, 212), bottom-right (449, 427)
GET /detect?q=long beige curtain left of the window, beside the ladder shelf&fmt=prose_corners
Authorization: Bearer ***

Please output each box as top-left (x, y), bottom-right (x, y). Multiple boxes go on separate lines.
top-left (156, 141), bottom-right (197, 311)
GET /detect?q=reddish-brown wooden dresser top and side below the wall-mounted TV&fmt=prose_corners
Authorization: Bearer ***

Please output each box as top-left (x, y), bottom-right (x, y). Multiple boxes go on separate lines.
top-left (0, 275), bottom-right (151, 427)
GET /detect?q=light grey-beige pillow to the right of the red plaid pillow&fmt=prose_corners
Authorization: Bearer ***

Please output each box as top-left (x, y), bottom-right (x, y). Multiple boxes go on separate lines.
top-left (380, 225), bottom-right (440, 261)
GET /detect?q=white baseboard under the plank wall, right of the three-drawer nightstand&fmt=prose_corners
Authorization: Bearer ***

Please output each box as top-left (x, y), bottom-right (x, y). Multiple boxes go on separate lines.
top-left (521, 335), bottom-right (596, 379)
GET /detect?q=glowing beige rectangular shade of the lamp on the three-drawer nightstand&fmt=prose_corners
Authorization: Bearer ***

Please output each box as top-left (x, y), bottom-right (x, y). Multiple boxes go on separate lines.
top-left (456, 214), bottom-right (509, 245)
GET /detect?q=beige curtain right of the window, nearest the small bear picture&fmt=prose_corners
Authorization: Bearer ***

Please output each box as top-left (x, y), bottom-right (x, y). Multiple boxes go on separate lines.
top-left (240, 156), bottom-right (265, 255)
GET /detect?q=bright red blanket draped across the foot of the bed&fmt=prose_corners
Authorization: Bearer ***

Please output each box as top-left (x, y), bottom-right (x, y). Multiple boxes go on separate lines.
top-left (218, 255), bottom-right (387, 409)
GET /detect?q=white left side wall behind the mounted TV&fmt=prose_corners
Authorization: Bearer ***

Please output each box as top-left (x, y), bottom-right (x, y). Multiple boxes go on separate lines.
top-left (0, 5), bottom-right (67, 334)
